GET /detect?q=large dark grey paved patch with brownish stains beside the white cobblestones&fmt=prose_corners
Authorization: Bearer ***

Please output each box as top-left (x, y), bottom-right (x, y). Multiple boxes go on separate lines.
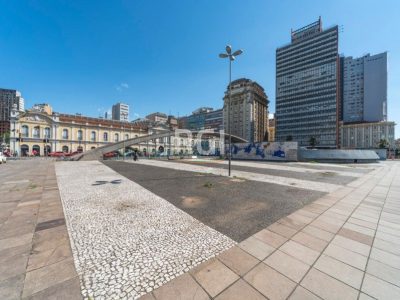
top-left (104, 161), bottom-right (325, 242)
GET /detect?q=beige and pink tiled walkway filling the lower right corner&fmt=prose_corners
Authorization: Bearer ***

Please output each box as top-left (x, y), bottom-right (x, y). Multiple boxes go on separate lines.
top-left (141, 162), bottom-right (400, 300)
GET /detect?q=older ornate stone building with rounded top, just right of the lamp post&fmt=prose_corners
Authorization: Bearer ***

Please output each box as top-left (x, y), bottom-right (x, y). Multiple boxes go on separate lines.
top-left (223, 78), bottom-right (269, 142)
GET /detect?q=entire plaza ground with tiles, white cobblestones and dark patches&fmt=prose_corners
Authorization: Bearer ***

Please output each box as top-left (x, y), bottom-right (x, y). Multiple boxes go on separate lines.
top-left (0, 159), bottom-right (400, 300)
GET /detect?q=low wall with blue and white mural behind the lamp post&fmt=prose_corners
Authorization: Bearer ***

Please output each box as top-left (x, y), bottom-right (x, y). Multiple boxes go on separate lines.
top-left (232, 142), bottom-right (298, 161)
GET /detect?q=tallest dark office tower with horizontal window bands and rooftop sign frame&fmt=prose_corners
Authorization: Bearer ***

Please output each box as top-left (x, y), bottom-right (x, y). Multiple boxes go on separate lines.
top-left (275, 18), bottom-right (340, 147)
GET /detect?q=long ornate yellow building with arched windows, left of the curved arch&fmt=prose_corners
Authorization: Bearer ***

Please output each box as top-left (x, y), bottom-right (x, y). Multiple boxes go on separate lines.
top-left (10, 104), bottom-right (148, 156)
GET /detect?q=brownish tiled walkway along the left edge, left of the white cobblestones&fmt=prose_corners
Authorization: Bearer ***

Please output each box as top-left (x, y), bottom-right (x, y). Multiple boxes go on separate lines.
top-left (0, 160), bottom-right (82, 300)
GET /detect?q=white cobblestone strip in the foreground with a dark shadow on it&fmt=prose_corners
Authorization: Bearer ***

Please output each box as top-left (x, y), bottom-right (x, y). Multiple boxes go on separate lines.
top-left (56, 161), bottom-right (235, 299)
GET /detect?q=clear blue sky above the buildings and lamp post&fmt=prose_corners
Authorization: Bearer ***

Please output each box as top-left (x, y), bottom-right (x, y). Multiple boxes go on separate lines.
top-left (0, 0), bottom-right (400, 136)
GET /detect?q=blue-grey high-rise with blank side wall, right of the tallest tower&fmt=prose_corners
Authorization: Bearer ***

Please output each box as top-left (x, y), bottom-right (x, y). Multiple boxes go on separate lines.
top-left (341, 52), bottom-right (387, 123)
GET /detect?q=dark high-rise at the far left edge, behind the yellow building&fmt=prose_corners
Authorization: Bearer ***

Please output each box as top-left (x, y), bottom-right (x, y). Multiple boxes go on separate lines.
top-left (0, 88), bottom-right (25, 135)
